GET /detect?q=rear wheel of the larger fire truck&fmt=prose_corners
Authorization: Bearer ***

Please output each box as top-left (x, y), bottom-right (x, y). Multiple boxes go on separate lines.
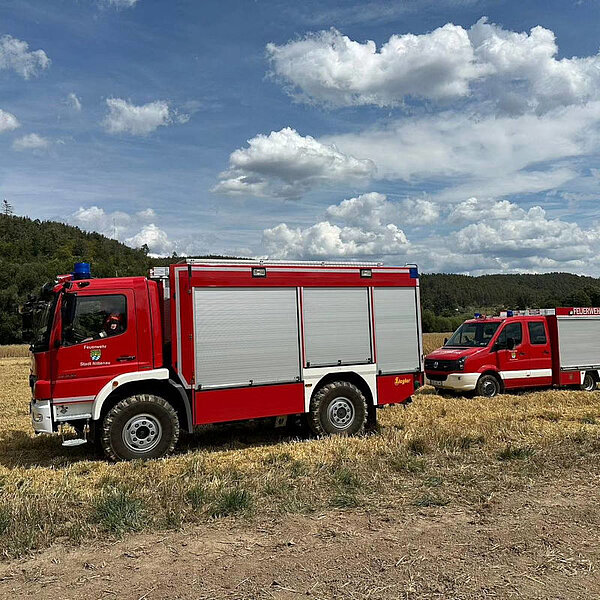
top-left (308, 381), bottom-right (368, 436)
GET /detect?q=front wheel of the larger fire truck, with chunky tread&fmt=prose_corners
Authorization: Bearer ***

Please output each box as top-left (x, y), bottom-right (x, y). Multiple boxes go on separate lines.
top-left (101, 394), bottom-right (179, 460)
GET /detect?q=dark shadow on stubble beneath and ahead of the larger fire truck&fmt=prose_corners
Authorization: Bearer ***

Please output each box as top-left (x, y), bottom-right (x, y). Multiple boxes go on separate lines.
top-left (0, 419), bottom-right (311, 469)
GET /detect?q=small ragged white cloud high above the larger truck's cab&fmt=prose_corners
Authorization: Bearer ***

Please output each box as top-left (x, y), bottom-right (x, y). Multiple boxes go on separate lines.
top-left (103, 98), bottom-right (179, 135)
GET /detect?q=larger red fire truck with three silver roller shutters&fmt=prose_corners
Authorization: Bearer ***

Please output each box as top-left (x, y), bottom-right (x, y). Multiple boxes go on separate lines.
top-left (30, 259), bottom-right (423, 459)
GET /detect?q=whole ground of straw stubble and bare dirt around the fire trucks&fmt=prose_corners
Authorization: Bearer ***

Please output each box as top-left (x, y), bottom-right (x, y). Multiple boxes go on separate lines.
top-left (0, 334), bottom-right (600, 600)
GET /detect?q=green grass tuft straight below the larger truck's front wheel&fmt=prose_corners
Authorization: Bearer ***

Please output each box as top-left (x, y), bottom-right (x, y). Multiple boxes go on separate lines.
top-left (94, 488), bottom-right (146, 535)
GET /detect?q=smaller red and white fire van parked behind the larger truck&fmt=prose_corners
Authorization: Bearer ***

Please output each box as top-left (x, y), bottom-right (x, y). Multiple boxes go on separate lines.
top-left (425, 308), bottom-right (600, 397)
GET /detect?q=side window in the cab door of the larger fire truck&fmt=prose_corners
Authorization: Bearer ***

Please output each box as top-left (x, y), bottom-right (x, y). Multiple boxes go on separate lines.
top-left (62, 294), bottom-right (127, 346)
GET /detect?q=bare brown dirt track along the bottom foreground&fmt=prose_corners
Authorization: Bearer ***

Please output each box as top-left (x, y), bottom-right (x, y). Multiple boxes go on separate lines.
top-left (0, 471), bottom-right (600, 600)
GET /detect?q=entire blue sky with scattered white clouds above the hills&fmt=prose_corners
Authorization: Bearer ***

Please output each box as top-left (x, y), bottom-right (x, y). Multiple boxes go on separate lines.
top-left (0, 0), bottom-right (600, 275)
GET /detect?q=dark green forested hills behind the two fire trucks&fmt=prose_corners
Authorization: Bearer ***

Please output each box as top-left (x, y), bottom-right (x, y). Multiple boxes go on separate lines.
top-left (0, 215), bottom-right (600, 344)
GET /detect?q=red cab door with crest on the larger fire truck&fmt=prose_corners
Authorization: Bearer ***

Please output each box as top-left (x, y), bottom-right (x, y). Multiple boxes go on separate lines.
top-left (52, 289), bottom-right (138, 401)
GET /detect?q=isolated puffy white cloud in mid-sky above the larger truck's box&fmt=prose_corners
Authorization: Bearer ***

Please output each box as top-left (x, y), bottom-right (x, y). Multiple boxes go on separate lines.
top-left (213, 127), bottom-right (376, 198)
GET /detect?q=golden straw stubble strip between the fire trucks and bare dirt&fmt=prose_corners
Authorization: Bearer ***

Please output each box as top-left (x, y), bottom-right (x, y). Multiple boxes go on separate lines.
top-left (0, 334), bottom-right (600, 557)
